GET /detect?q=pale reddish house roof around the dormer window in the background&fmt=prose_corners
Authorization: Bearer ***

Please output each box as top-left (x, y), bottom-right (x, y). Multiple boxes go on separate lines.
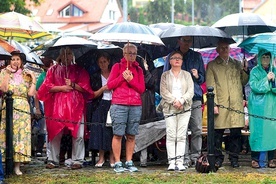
top-left (26, 0), bottom-right (122, 32)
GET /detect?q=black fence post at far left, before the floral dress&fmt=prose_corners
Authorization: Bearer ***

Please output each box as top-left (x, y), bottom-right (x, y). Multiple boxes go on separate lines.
top-left (5, 91), bottom-right (13, 176)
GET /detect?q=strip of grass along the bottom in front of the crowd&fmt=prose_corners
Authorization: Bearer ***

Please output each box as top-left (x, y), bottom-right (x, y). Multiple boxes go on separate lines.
top-left (3, 168), bottom-right (276, 184)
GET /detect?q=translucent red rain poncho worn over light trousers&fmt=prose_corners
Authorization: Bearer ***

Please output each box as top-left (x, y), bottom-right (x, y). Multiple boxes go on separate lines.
top-left (37, 64), bottom-right (94, 141)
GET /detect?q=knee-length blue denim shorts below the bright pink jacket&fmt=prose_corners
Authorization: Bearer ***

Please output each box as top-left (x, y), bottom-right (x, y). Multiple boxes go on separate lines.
top-left (110, 104), bottom-right (142, 136)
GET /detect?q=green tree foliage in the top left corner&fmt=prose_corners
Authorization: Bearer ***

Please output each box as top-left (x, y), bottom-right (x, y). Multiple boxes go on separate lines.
top-left (0, 0), bottom-right (41, 15)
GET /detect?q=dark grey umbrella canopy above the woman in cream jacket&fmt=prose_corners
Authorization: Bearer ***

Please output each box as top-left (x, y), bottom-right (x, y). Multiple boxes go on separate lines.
top-left (160, 25), bottom-right (235, 49)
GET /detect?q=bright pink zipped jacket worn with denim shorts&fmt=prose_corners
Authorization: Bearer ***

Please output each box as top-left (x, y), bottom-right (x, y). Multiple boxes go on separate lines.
top-left (107, 58), bottom-right (145, 106)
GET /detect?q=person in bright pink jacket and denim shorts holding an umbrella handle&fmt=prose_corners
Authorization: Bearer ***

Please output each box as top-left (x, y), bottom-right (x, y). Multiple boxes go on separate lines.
top-left (107, 43), bottom-right (145, 172)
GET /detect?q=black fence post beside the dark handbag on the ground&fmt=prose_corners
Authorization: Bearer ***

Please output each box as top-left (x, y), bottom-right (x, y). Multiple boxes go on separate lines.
top-left (207, 86), bottom-right (216, 172)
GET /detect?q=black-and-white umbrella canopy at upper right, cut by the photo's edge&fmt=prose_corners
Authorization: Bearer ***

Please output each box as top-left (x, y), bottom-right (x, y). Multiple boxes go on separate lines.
top-left (212, 13), bottom-right (276, 35)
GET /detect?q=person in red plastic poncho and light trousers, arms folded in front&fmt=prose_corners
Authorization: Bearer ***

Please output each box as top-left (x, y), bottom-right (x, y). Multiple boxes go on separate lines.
top-left (38, 47), bottom-right (94, 169)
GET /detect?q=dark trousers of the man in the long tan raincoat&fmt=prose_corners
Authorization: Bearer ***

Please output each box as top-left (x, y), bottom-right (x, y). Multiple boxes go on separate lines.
top-left (215, 128), bottom-right (241, 163)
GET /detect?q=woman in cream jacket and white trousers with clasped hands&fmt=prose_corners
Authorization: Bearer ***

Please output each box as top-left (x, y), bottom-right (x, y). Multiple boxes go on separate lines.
top-left (160, 51), bottom-right (194, 171)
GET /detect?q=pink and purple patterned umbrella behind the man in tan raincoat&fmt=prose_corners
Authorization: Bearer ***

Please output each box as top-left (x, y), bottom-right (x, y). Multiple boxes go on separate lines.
top-left (197, 44), bottom-right (254, 66)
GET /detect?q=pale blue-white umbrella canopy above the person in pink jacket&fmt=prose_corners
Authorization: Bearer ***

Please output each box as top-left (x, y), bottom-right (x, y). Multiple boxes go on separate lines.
top-left (91, 22), bottom-right (163, 45)
